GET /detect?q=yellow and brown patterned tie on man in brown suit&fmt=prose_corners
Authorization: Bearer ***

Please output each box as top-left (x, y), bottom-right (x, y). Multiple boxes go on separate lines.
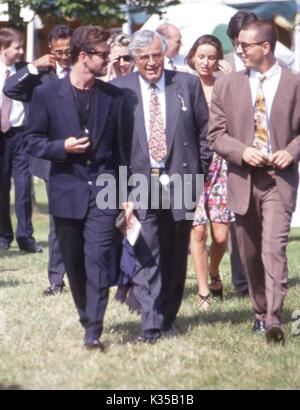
top-left (253, 76), bottom-right (270, 154)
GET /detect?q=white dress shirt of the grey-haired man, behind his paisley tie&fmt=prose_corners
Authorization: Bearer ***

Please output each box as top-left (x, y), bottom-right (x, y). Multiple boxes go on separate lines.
top-left (139, 74), bottom-right (166, 168)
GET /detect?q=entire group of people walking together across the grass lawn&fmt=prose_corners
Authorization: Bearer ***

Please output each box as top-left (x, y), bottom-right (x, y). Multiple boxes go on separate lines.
top-left (0, 11), bottom-right (300, 351)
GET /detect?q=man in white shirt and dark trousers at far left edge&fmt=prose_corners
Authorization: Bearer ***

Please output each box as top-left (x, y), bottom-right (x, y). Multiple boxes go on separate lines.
top-left (0, 28), bottom-right (42, 253)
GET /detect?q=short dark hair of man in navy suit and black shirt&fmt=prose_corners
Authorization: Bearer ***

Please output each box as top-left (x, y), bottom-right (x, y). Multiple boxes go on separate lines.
top-left (70, 25), bottom-right (110, 64)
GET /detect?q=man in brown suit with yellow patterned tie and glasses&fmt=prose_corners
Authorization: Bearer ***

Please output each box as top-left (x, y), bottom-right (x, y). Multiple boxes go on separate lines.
top-left (208, 21), bottom-right (300, 344)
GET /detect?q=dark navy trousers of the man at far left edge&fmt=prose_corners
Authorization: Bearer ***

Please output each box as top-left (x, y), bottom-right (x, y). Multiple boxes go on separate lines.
top-left (0, 128), bottom-right (34, 247)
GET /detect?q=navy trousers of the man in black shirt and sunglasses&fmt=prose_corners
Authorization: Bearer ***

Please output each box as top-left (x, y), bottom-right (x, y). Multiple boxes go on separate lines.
top-left (54, 200), bottom-right (116, 341)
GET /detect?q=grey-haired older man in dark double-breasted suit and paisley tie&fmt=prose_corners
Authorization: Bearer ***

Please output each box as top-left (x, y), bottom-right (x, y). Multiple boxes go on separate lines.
top-left (114, 30), bottom-right (212, 343)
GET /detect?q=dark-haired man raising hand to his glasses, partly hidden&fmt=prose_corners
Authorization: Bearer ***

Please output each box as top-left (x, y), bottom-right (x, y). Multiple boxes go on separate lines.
top-left (3, 25), bottom-right (72, 296)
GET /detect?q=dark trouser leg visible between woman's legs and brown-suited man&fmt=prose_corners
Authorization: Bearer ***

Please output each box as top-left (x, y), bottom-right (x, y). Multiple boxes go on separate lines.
top-left (228, 222), bottom-right (248, 294)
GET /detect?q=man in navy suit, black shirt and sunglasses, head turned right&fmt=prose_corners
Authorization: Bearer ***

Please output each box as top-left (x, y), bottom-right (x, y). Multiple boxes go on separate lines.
top-left (25, 26), bottom-right (130, 351)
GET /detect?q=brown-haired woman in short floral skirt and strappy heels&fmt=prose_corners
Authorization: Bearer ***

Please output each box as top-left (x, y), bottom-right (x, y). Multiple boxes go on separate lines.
top-left (186, 35), bottom-right (234, 311)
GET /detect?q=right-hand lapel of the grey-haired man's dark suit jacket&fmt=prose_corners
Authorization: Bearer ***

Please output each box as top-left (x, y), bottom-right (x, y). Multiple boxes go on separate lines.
top-left (165, 71), bottom-right (183, 160)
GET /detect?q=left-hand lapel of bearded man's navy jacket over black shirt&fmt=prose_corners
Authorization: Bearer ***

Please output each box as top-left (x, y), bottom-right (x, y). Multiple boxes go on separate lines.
top-left (58, 77), bottom-right (81, 137)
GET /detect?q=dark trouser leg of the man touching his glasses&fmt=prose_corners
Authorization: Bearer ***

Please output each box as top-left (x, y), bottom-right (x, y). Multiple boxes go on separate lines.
top-left (46, 182), bottom-right (66, 286)
